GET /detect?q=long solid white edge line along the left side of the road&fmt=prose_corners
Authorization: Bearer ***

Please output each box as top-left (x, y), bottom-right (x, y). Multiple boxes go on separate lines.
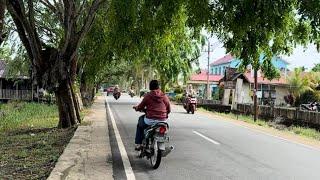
top-left (105, 96), bottom-right (136, 180)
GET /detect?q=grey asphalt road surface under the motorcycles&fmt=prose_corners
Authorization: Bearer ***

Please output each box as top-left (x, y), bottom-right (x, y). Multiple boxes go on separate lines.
top-left (107, 95), bottom-right (320, 180)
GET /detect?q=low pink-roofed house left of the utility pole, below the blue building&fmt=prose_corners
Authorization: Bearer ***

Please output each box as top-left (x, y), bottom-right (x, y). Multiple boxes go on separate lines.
top-left (187, 70), bottom-right (223, 97)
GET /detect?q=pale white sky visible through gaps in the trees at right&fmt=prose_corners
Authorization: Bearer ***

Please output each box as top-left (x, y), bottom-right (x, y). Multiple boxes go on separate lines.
top-left (199, 38), bottom-right (320, 70)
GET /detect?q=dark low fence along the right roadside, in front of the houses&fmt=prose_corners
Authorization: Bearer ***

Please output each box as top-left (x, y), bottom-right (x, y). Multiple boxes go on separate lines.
top-left (237, 104), bottom-right (320, 127)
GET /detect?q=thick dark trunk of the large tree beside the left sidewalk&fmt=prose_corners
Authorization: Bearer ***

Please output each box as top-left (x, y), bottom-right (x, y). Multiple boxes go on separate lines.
top-left (55, 81), bottom-right (80, 128)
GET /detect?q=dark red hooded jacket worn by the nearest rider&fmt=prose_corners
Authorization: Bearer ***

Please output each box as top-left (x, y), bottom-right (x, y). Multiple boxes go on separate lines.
top-left (136, 89), bottom-right (171, 120)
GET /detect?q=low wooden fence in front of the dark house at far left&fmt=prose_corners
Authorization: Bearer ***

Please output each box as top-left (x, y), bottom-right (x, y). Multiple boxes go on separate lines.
top-left (0, 89), bottom-right (32, 100)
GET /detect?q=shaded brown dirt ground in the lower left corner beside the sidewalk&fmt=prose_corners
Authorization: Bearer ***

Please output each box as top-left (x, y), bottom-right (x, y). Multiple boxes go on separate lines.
top-left (0, 128), bottom-right (75, 179)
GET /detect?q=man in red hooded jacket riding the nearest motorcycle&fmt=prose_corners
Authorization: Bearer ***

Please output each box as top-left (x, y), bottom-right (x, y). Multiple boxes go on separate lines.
top-left (133, 80), bottom-right (171, 150)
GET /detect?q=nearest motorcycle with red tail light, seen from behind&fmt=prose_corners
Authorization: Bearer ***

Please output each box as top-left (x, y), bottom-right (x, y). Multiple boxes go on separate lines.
top-left (138, 116), bottom-right (174, 169)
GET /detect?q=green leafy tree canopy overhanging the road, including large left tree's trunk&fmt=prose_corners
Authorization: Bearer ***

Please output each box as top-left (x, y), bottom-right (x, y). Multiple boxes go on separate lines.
top-left (0, 0), bottom-right (320, 127)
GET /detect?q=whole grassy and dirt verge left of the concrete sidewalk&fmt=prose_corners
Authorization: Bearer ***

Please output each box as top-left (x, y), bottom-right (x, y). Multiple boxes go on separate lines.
top-left (0, 101), bottom-right (75, 179)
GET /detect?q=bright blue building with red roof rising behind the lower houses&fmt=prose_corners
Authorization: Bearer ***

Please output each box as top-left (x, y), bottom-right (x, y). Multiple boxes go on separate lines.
top-left (210, 54), bottom-right (289, 76)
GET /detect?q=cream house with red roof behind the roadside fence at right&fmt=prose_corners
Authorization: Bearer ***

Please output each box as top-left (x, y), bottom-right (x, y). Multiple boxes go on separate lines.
top-left (220, 67), bottom-right (289, 108)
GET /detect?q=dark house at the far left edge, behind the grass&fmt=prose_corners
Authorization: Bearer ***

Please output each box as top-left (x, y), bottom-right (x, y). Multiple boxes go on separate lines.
top-left (0, 60), bottom-right (32, 101)
